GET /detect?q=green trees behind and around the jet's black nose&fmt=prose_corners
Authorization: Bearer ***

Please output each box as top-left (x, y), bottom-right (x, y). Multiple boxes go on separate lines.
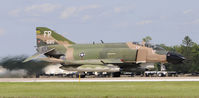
top-left (161, 36), bottom-right (199, 73)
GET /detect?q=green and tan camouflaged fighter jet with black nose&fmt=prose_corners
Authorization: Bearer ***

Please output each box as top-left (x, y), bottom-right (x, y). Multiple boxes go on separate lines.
top-left (24, 27), bottom-right (185, 76)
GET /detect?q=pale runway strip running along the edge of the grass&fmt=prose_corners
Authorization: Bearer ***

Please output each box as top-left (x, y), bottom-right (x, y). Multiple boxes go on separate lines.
top-left (0, 77), bottom-right (199, 82)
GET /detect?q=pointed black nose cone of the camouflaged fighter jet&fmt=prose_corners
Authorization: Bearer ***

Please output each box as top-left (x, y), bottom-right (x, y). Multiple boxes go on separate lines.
top-left (167, 52), bottom-right (186, 64)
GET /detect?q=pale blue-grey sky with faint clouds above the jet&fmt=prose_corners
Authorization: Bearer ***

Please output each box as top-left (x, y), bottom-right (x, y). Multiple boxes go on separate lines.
top-left (0, 0), bottom-right (199, 57)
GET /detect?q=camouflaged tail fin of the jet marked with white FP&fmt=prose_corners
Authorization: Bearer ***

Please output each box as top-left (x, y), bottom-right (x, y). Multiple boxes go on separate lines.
top-left (36, 27), bottom-right (75, 47)
